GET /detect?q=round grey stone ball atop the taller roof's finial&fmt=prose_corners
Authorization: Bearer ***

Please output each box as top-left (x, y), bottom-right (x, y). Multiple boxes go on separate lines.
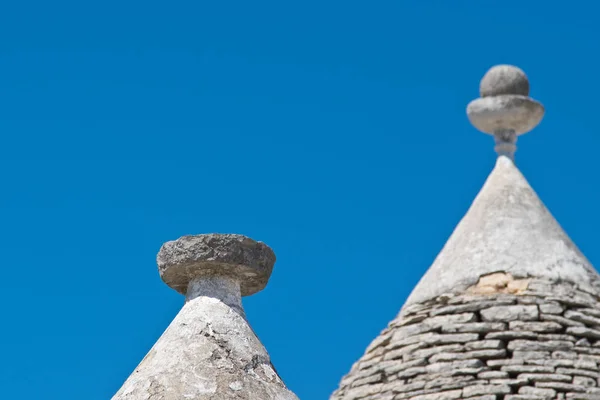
top-left (479, 65), bottom-right (529, 97)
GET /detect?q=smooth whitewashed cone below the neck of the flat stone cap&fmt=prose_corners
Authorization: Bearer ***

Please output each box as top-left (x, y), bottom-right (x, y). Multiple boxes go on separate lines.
top-left (113, 278), bottom-right (296, 400)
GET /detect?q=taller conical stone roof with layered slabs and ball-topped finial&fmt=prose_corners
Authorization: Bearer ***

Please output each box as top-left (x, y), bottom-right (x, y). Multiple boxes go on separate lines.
top-left (331, 65), bottom-right (600, 400)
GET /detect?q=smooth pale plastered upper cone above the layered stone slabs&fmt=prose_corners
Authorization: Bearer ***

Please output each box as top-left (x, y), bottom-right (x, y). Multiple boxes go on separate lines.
top-left (405, 156), bottom-right (600, 307)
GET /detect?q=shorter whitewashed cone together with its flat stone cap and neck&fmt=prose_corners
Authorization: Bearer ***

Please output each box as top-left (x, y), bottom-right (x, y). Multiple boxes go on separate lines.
top-left (113, 234), bottom-right (297, 400)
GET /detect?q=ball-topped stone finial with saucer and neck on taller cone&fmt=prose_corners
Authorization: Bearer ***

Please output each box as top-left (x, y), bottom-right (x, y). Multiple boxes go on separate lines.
top-left (467, 65), bottom-right (544, 159)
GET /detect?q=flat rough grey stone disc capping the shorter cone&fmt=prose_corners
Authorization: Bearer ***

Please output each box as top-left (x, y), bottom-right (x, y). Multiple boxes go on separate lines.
top-left (156, 233), bottom-right (275, 296)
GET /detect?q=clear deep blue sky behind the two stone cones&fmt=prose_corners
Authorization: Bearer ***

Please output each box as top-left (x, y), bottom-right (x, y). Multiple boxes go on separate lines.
top-left (0, 0), bottom-right (600, 400)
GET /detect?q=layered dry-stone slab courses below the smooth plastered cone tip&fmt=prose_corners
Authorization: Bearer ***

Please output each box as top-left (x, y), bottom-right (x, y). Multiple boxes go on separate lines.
top-left (331, 274), bottom-right (600, 400)
